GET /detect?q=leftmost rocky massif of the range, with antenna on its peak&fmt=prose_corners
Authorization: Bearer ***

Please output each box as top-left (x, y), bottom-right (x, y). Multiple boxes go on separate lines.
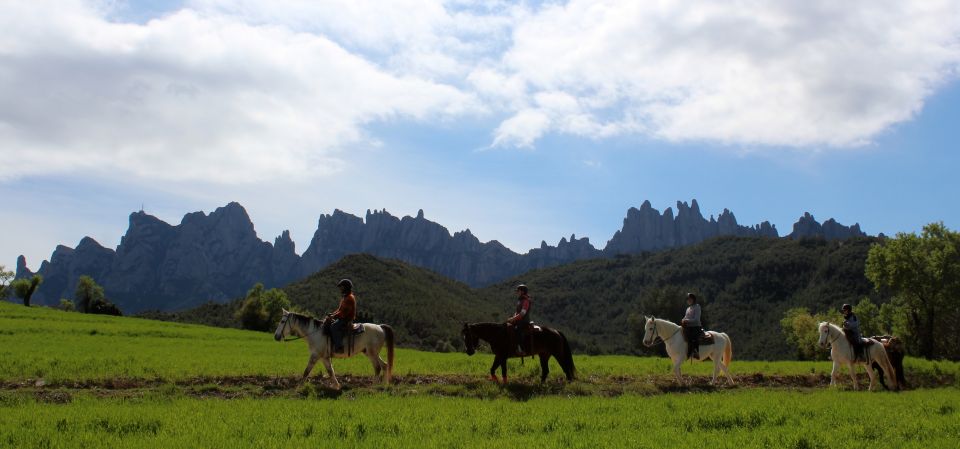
top-left (18, 203), bottom-right (299, 312)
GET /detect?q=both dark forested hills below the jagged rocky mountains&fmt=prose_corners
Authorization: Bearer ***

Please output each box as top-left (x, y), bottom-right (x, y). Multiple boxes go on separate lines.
top-left (152, 237), bottom-right (882, 359)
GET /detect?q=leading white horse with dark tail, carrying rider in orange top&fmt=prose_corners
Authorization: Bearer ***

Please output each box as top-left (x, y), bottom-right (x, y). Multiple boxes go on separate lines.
top-left (273, 309), bottom-right (394, 390)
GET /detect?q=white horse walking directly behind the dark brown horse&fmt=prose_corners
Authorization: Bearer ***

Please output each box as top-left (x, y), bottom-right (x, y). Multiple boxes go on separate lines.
top-left (643, 316), bottom-right (734, 384)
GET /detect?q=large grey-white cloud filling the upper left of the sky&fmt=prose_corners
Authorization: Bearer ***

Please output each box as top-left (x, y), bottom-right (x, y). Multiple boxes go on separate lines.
top-left (0, 2), bottom-right (480, 183)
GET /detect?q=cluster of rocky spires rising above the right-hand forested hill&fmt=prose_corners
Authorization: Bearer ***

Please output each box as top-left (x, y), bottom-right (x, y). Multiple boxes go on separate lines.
top-left (604, 200), bottom-right (778, 255)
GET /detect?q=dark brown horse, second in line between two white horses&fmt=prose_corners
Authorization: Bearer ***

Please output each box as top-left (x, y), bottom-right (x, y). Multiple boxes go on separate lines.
top-left (461, 323), bottom-right (576, 383)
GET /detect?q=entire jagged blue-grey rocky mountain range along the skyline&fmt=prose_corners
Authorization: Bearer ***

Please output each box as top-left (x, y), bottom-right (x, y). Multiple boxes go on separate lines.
top-left (17, 200), bottom-right (864, 312)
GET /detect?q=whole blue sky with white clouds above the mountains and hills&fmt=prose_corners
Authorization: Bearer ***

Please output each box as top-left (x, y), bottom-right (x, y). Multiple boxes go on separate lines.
top-left (0, 0), bottom-right (960, 269)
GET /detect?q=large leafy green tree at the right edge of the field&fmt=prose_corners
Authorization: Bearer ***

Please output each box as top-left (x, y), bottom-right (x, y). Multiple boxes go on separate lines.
top-left (866, 223), bottom-right (960, 359)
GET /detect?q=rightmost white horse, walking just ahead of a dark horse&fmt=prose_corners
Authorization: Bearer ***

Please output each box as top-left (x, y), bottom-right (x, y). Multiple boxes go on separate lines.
top-left (817, 321), bottom-right (899, 391)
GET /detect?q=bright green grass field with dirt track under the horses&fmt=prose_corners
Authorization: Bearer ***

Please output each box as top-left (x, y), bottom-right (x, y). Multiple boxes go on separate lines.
top-left (0, 303), bottom-right (960, 449)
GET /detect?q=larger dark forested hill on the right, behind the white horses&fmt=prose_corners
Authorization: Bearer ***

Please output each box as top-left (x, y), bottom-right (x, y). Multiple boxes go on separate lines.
top-left (480, 237), bottom-right (883, 359)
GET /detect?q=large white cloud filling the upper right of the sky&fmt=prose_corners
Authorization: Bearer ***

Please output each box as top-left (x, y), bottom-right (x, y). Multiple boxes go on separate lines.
top-left (496, 0), bottom-right (960, 147)
